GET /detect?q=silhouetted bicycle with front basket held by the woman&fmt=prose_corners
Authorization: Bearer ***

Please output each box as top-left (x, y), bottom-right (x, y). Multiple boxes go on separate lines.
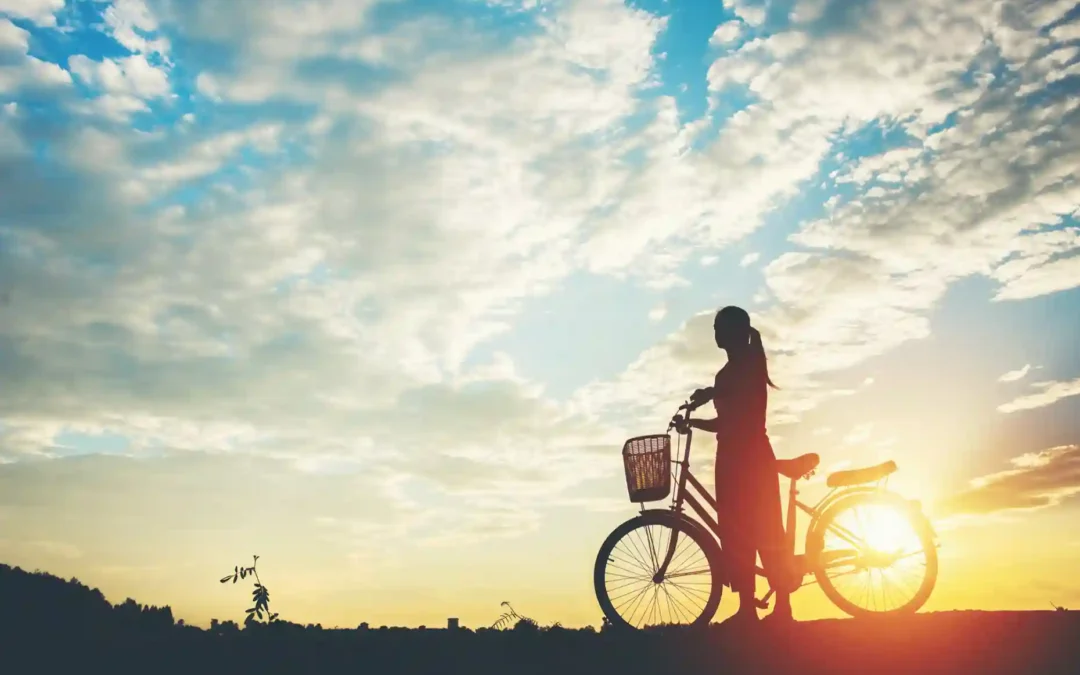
top-left (593, 393), bottom-right (939, 629)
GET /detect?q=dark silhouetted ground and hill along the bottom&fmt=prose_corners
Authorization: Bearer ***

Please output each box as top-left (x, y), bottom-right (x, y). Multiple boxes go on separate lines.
top-left (0, 565), bottom-right (1080, 675)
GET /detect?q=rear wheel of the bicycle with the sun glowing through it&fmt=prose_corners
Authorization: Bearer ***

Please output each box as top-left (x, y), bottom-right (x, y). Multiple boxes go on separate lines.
top-left (806, 492), bottom-right (937, 617)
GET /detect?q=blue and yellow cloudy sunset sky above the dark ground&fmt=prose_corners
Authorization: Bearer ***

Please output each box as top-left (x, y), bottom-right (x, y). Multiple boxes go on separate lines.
top-left (0, 0), bottom-right (1080, 627)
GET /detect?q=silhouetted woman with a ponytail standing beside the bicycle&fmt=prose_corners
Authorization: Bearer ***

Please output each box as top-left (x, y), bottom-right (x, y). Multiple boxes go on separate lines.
top-left (676, 307), bottom-right (794, 623)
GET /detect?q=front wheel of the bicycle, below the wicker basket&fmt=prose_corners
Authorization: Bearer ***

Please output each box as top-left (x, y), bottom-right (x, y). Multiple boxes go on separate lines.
top-left (593, 511), bottom-right (724, 629)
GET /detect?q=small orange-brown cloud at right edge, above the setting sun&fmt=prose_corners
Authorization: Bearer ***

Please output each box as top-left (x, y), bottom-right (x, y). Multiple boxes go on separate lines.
top-left (942, 445), bottom-right (1080, 516)
